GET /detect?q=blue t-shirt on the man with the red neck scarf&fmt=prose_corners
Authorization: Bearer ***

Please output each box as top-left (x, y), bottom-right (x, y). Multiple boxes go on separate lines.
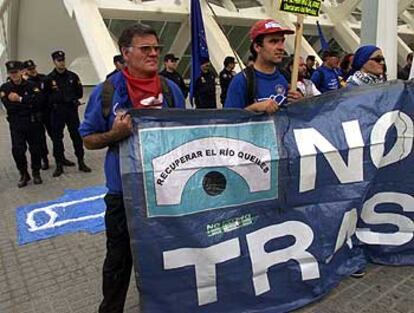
top-left (79, 72), bottom-right (185, 194)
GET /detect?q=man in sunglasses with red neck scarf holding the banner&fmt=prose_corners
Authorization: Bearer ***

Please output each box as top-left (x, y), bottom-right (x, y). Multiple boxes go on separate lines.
top-left (80, 24), bottom-right (185, 313)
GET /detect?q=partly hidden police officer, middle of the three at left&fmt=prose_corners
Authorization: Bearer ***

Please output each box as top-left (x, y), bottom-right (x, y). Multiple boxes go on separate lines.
top-left (23, 60), bottom-right (53, 170)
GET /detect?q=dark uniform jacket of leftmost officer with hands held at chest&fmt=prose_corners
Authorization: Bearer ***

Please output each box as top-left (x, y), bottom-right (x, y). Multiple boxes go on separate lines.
top-left (0, 79), bottom-right (44, 124)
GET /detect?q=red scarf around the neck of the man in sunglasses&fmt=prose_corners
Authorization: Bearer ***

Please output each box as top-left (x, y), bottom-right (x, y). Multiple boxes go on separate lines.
top-left (122, 68), bottom-right (163, 109)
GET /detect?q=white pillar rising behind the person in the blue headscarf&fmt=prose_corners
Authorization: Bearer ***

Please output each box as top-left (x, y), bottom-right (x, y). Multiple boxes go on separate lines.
top-left (361, 0), bottom-right (398, 79)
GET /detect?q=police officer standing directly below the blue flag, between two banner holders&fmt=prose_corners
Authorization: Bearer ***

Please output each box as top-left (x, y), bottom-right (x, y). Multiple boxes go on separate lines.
top-left (194, 59), bottom-right (217, 109)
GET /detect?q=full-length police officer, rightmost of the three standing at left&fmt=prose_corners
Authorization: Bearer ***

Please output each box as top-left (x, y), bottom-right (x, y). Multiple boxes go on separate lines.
top-left (48, 51), bottom-right (91, 177)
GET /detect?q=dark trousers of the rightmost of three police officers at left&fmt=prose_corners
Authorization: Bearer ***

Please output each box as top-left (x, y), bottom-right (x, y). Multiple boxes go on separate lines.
top-left (52, 105), bottom-right (85, 163)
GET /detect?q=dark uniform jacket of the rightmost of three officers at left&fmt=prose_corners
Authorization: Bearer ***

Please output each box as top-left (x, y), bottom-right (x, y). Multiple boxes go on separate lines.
top-left (48, 69), bottom-right (83, 110)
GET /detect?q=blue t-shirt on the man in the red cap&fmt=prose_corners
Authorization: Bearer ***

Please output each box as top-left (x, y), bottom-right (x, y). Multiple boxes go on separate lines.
top-left (224, 70), bottom-right (288, 109)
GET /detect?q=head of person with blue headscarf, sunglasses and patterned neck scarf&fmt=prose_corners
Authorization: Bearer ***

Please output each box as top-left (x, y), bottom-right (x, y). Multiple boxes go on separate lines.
top-left (346, 45), bottom-right (385, 86)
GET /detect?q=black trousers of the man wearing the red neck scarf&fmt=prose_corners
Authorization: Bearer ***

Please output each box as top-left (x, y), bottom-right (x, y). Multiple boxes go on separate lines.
top-left (99, 194), bottom-right (132, 313)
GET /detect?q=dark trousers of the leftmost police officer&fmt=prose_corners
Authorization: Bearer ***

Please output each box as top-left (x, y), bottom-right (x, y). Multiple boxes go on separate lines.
top-left (10, 118), bottom-right (42, 173)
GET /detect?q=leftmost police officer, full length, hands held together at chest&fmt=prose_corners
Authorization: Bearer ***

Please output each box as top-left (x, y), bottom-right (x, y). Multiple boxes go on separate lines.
top-left (0, 61), bottom-right (42, 188)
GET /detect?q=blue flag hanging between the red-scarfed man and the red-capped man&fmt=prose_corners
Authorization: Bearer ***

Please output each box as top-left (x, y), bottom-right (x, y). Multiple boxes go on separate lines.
top-left (190, 0), bottom-right (209, 104)
